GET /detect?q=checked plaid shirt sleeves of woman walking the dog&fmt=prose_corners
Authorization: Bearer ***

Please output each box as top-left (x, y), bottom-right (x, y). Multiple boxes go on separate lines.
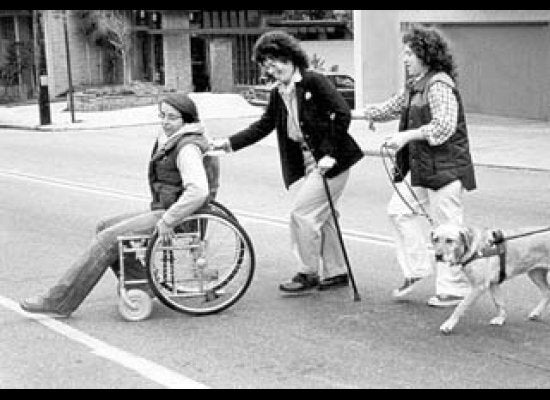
top-left (364, 82), bottom-right (458, 146)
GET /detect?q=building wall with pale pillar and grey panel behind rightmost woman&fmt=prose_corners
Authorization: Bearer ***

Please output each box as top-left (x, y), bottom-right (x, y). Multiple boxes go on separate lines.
top-left (354, 10), bottom-right (550, 120)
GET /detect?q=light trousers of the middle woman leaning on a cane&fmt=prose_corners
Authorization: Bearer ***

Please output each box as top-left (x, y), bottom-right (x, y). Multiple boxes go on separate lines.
top-left (290, 168), bottom-right (350, 278)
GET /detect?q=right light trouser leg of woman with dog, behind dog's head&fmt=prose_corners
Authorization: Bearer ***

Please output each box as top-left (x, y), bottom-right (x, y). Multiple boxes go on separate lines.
top-left (429, 180), bottom-right (470, 296)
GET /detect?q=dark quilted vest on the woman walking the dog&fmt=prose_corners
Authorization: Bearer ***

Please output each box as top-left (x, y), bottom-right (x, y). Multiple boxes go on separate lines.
top-left (396, 72), bottom-right (476, 190)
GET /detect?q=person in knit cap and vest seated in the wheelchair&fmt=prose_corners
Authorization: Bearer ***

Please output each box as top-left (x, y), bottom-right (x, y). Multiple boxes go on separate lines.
top-left (20, 94), bottom-right (219, 317)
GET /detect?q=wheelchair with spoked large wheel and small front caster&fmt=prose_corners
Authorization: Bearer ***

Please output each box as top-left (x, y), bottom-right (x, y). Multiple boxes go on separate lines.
top-left (118, 200), bottom-right (255, 321)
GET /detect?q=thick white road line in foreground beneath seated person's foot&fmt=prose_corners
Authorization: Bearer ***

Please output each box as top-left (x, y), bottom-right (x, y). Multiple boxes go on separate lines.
top-left (0, 296), bottom-right (208, 389)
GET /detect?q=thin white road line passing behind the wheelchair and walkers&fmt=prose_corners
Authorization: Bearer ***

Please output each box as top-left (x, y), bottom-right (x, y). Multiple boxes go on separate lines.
top-left (0, 170), bottom-right (394, 246)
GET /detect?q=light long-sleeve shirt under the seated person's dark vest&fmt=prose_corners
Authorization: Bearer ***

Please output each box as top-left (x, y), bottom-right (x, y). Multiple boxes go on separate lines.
top-left (158, 124), bottom-right (209, 226)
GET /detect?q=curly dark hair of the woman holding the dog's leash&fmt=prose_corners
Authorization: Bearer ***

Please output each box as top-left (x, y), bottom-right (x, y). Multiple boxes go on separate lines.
top-left (403, 25), bottom-right (458, 82)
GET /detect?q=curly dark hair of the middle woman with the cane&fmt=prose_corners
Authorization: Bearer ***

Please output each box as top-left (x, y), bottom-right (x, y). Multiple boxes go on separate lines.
top-left (253, 31), bottom-right (309, 72)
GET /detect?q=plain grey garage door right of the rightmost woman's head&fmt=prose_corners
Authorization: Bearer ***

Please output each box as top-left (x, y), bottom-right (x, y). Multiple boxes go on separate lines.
top-left (440, 23), bottom-right (550, 119)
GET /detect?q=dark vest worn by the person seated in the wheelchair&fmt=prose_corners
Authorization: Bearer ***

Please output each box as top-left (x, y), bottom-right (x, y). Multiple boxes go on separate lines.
top-left (148, 133), bottom-right (220, 210)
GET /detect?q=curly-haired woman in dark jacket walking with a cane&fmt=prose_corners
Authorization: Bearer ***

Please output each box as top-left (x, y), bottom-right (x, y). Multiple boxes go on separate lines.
top-left (212, 31), bottom-right (363, 293)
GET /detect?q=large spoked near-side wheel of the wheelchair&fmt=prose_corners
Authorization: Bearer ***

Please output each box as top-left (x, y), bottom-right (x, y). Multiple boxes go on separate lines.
top-left (145, 209), bottom-right (255, 315)
